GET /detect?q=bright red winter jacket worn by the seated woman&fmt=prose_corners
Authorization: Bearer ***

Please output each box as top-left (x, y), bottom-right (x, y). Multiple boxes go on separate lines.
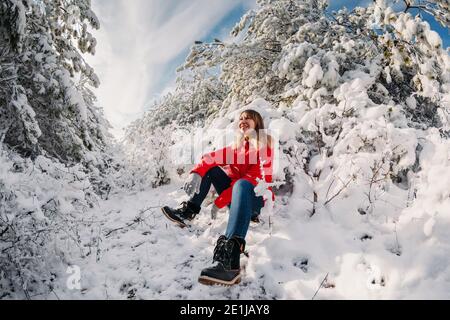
top-left (191, 141), bottom-right (275, 208)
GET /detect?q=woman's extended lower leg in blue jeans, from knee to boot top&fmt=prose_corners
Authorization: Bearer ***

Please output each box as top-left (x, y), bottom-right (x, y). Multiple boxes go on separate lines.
top-left (225, 179), bottom-right (260, 239)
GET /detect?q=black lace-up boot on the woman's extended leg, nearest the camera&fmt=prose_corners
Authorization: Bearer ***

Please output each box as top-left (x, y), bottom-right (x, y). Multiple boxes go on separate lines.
top-left (198, 236), bottom-right (245, 286)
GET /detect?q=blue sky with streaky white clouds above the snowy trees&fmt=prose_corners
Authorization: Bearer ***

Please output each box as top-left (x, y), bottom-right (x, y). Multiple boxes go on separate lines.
top-left (87, 0), bottom-right (450, 138)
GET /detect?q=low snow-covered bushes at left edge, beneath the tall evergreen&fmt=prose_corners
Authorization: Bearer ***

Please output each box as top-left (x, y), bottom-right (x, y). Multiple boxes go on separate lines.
top-left (0, 146), bottom-right (99, 299)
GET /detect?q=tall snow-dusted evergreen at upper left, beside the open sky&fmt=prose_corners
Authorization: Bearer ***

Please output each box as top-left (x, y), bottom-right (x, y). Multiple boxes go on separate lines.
top-left (0, 0), bottom-right (107, 162)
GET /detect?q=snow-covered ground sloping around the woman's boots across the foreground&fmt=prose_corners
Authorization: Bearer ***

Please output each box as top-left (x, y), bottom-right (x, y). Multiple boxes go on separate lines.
top-left (51, 165), bottom-right (450, 299)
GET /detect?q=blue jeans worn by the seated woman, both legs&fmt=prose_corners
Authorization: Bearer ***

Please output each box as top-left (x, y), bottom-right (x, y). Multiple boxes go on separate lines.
top-left (189, 167), bottom-right (264, 239)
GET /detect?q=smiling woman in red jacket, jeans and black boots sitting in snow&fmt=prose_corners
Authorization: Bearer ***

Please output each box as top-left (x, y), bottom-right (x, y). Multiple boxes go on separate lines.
top-left (162, 110), bottom-right (274, 285)
